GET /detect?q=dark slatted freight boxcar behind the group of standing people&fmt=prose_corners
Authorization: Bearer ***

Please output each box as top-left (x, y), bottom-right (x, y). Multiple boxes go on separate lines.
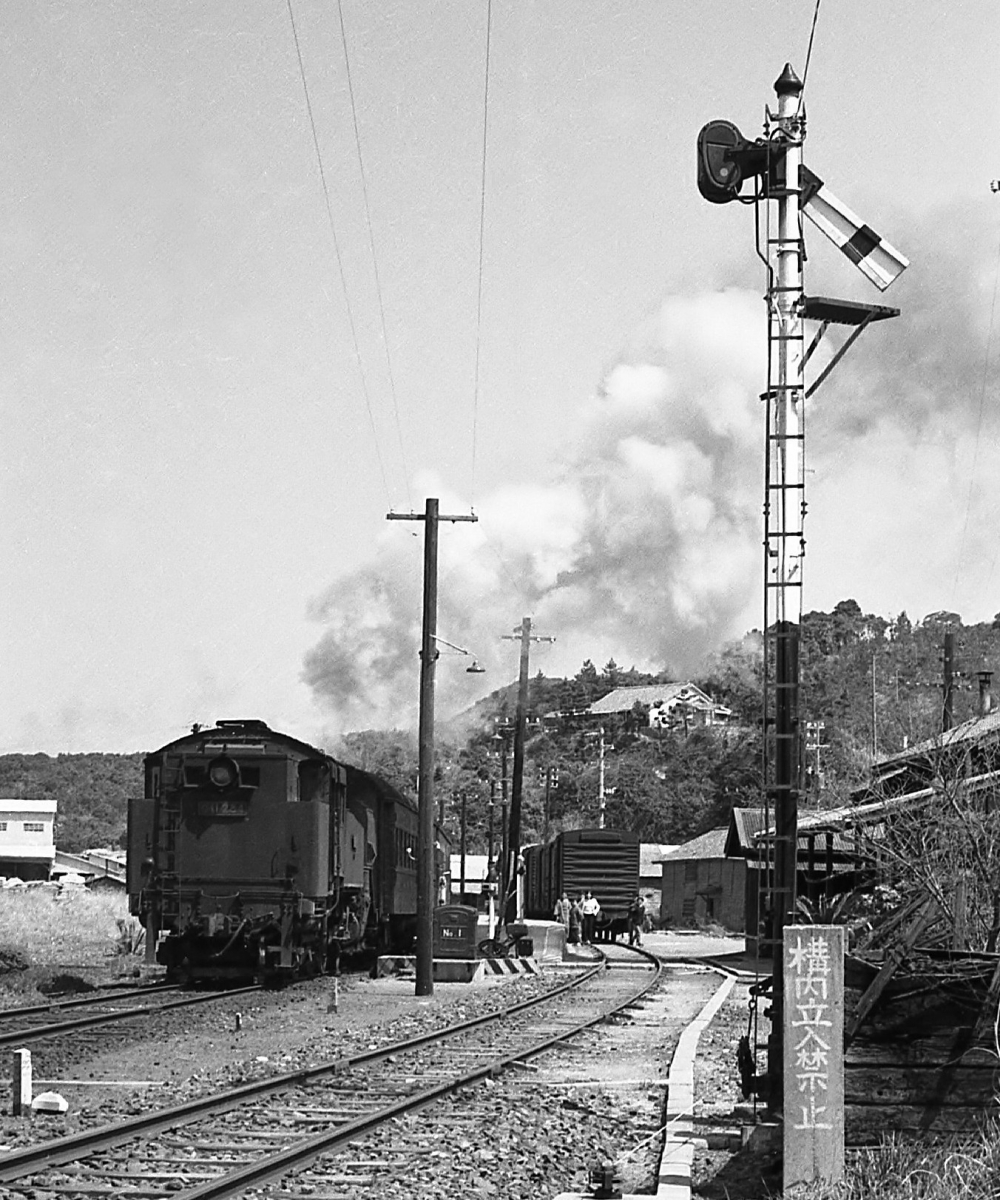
top-left (523, 829), bottom-right (639, 937)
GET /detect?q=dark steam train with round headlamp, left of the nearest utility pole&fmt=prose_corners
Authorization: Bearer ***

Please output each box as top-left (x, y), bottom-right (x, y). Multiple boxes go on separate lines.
top-left (127, 720), bottom-right (432, 983)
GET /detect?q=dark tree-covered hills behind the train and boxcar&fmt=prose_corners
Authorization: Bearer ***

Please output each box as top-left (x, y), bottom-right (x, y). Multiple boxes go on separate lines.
top-left (0, 600), bottom-right (1000, 853)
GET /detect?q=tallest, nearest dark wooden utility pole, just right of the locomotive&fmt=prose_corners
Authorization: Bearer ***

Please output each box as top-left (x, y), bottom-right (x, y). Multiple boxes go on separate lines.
top-left (385, 499), bottom-right (479, 996)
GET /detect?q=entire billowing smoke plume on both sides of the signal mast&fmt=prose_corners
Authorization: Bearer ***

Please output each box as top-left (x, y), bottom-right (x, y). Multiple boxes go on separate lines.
top-left (305, 199), bottom-right (1000, 728)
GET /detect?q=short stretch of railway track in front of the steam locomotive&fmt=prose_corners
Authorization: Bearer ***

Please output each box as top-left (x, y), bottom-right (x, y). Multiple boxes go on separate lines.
top-left (0, 984), bottom-right (261, 1046)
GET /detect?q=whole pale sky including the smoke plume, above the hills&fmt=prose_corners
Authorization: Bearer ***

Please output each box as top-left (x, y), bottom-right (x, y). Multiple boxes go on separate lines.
top-left (0, 0), bottom-right (1000, 754)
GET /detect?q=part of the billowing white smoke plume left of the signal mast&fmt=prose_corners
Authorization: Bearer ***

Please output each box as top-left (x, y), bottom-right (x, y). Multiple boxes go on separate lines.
top-left (305, 290), bottom-right (765, 727)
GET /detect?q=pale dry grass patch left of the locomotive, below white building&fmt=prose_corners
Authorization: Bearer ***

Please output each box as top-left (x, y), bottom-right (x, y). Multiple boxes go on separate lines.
top-left (0, 887), bottom-right (140, 994)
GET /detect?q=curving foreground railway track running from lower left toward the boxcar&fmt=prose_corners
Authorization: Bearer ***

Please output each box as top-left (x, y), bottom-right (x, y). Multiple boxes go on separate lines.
top-left (0, 947), bottom-right (660, 1200)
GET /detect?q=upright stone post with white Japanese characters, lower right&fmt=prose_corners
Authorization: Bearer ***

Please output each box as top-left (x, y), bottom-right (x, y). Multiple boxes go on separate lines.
top-left (783, 925), bottom-right (844, 1189)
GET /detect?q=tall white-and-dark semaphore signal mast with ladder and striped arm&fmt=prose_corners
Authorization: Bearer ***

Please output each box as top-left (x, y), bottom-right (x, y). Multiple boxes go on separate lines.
top-left (697, 64), bottom-right (909, 1114)
